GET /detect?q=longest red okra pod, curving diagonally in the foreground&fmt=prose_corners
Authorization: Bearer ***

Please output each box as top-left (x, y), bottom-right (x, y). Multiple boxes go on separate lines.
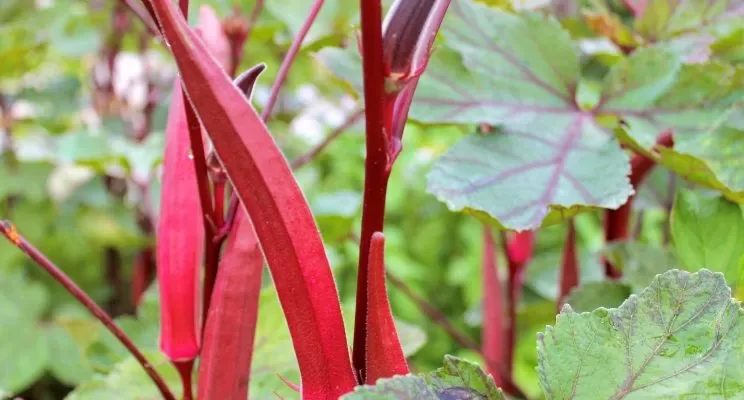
top-left (145, 0), bottom-right (356, 400)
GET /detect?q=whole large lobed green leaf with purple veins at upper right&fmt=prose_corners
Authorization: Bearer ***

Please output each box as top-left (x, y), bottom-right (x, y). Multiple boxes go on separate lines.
top-left (319, 0), bottom-right (744, 229)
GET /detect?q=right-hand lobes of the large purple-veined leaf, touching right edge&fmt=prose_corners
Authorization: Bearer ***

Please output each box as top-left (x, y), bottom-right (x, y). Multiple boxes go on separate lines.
top-left (597, 54), bottom-right (744, 201)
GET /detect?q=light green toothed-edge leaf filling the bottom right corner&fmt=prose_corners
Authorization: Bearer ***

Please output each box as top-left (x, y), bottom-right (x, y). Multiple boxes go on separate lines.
top-left (538, 270), bottom-right (744, 399)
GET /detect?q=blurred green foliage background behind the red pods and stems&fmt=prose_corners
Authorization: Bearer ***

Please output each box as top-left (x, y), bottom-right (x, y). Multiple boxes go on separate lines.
top-left (0, 0), bottom-right (740, 400)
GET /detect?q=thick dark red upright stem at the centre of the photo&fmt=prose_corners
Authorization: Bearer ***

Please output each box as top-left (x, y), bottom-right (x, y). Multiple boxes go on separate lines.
top-left (352, 0), bottom-right (390, 382)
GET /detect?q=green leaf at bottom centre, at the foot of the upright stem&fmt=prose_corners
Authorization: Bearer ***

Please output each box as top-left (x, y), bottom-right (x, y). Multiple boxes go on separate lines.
top-left (341, 356), bottom-right (505, 400)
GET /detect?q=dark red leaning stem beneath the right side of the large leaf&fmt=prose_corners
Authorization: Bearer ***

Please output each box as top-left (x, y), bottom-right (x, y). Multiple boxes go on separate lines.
top-left (604, 131), bottom-right (674, 279)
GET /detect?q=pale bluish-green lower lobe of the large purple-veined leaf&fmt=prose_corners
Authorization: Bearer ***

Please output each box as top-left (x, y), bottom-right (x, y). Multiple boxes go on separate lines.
top-left (428, 131), bottom-right (632, 230)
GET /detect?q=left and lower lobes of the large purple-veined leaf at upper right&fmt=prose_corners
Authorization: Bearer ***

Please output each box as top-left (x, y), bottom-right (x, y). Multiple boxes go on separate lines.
top-left (411, 1), bottom-right (632, 230)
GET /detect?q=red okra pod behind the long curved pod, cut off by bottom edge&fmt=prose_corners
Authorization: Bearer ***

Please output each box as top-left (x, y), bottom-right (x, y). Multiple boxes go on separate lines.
top-left (197, 210), bottom-right (264, 399)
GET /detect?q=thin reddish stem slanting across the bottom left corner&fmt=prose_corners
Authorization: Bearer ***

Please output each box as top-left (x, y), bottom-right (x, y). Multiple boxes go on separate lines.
top-left (0, 221), bottom-right (176, 400)
